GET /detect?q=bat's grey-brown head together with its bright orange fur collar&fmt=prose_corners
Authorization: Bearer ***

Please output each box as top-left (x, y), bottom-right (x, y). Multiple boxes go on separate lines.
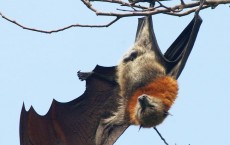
top-left (127, 76), bottom-right (178, 127)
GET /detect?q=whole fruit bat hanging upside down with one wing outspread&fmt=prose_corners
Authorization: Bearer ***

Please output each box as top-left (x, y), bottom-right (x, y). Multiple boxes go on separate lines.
top-left (19, 14), bottom-right (202, 145)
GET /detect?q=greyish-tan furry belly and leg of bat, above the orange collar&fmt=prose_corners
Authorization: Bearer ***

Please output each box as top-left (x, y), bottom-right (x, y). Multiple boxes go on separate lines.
top-left (117, 16), bottom-right (166, 97)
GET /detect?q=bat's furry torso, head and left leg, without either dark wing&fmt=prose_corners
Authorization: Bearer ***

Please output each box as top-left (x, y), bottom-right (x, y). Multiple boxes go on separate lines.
top-left (102, 17), bottom-right (178, 127)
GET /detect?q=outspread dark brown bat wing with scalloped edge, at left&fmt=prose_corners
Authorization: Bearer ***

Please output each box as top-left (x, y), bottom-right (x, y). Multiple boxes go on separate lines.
top-left (20, 66), bottom-right (128, 145)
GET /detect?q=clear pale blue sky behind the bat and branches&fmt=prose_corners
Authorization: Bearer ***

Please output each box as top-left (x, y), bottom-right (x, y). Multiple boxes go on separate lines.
top-left (0, 0), bottom-right (230, 145)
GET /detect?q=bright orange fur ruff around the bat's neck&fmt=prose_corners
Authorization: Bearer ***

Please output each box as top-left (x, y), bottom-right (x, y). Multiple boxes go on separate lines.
top-left (127, 76), bottom-right (178, 124)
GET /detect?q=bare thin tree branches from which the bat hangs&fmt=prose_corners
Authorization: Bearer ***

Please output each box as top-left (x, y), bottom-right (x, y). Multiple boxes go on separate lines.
top-left (0, 0), bottom-right (230, 34)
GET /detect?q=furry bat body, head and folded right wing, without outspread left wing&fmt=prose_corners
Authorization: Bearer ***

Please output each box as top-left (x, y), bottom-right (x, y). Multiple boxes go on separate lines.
top-left (103, 15), bottom-right (202, 127)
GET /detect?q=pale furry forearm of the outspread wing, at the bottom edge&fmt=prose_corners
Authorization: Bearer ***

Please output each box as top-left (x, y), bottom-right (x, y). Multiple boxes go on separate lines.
top-left (95, 121), bottom-right (128, 145)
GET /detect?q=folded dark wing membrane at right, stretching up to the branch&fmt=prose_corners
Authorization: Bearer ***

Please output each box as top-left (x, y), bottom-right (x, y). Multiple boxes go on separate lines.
top-left (164, 15), bottom-right (202, 79)
